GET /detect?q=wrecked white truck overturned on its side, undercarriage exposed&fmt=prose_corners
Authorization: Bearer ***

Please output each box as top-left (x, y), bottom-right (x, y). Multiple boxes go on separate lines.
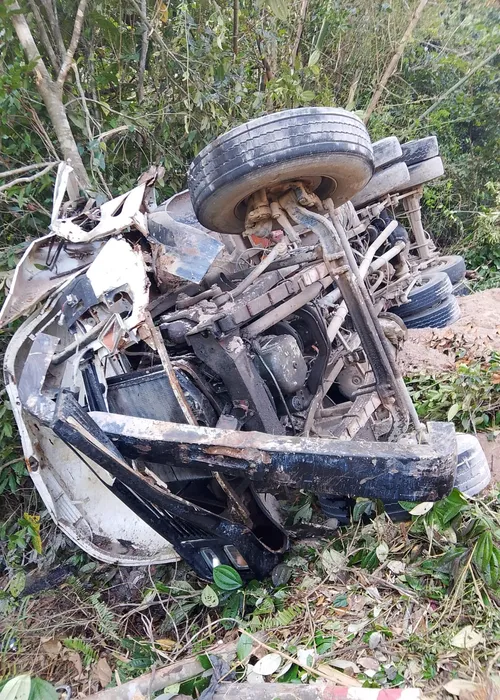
top-left (0, 108), bottom-right (489, 580)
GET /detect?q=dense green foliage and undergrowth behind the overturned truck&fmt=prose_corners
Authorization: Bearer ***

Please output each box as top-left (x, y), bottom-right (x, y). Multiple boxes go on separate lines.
top-left (0, 0), bottom-right (500, 246)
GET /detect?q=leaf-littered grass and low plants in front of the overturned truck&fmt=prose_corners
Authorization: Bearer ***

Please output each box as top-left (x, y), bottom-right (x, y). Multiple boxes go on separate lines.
top-left (0, 490), bottom-right (500, 694)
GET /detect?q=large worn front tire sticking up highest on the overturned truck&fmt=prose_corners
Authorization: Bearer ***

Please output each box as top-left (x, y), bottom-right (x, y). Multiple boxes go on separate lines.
top-left (188, 107), bottom-right (373, 233)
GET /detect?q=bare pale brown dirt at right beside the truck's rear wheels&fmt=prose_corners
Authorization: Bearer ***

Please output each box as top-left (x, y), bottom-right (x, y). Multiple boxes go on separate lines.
top-left (398, 289), bottom-right (500, 483)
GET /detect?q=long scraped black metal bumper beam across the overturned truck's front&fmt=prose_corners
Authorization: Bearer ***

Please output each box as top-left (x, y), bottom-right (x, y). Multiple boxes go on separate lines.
top-left (88, 413), bottom-right (456, 501)
